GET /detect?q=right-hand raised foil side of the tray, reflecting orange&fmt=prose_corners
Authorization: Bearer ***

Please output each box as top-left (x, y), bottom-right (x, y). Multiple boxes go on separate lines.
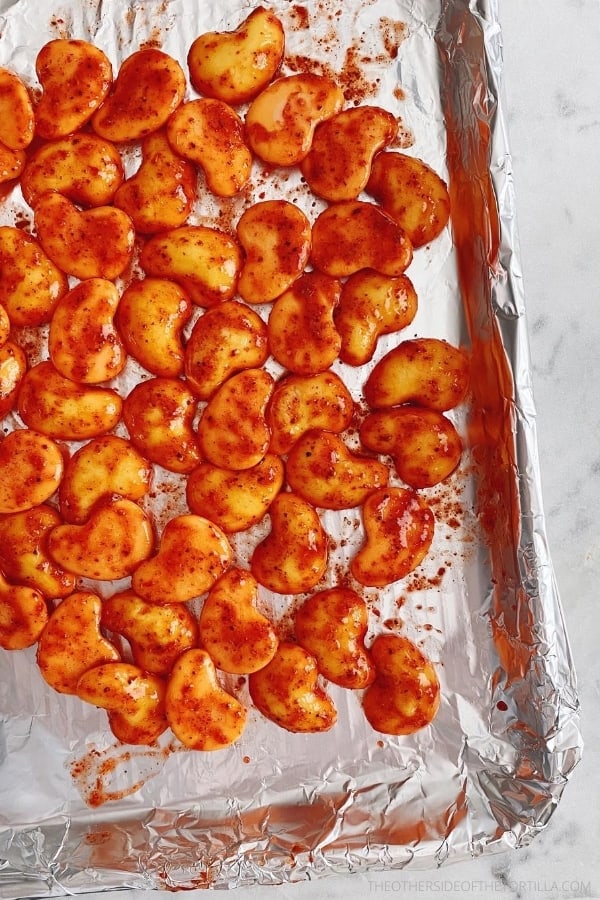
top-left (436, 0), bottom-right (582, 850)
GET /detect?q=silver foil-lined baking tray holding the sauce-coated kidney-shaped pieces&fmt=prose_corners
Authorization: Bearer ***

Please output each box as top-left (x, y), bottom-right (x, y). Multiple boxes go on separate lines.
top-left (0, 0), bottom-right (582, 898)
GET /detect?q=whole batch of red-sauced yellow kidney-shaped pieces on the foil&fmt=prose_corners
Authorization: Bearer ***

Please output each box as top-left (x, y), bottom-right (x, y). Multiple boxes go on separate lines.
top-left (0, 7), bottom-right (468, 750)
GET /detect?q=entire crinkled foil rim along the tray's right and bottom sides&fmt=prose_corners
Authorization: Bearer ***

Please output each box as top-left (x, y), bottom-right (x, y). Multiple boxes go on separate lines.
top-left (0, 0), bottom-right (582, 900)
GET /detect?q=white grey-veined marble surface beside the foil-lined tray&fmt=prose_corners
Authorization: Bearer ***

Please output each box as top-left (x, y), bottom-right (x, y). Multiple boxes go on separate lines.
top-left (5, 0), bottom-right (600, 900)
